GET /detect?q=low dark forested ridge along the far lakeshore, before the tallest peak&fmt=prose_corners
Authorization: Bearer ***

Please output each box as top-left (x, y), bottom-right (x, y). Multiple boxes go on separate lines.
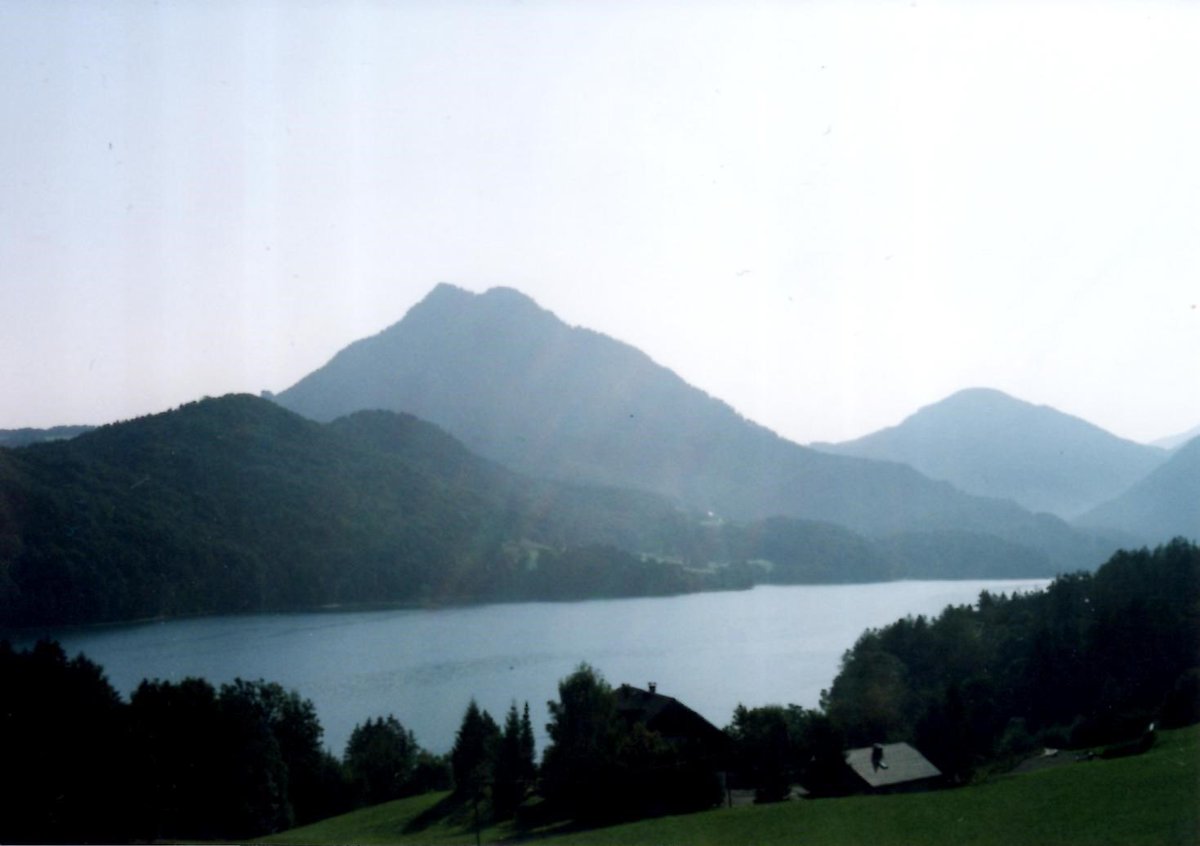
top-left (0, 396), bottom-right (1099, 628)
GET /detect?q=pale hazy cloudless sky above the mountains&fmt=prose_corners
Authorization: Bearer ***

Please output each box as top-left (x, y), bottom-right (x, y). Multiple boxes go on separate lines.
top-left (0, 0), bottom-right (1200, 443)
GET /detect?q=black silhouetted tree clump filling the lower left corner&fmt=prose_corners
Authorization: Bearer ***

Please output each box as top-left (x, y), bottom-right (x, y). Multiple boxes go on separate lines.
top-left (0, 641), bottom-right (450, 842)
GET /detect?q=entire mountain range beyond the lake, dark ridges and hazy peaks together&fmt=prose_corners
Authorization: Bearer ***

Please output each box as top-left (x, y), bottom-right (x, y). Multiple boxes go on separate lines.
top-left (0, 280), bottom-right (1200, 628)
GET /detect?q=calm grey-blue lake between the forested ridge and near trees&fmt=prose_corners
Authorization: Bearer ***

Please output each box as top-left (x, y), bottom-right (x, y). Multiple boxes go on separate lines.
top-left (18, 580), bottom-right (1048, 755)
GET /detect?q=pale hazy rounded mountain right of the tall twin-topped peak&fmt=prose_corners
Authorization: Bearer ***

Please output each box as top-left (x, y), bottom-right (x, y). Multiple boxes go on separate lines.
top-left (820, 388), bottom-right (1166, 517)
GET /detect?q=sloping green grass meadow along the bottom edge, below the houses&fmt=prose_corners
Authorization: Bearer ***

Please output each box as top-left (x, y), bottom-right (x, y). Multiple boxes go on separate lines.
top-left (264, 727), bottom-right (1200, 846)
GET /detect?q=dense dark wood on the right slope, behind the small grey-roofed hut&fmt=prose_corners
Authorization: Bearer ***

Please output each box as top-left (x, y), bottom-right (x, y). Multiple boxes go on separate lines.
top-left (823, 540), bottom-right (1200, 779)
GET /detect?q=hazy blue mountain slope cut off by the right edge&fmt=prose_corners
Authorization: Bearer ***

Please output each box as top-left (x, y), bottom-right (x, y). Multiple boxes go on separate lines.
top-left (1076, 438), bottom-right (1200, 544)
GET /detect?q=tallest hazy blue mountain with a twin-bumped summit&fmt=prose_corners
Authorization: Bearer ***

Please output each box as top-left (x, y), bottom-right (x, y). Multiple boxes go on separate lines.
top-left (275, 284), bottom-right (1104, 568)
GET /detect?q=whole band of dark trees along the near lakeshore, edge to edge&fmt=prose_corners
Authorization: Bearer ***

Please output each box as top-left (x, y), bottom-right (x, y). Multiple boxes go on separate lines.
top-left (0, 540), bottom-right (1200, 842)
